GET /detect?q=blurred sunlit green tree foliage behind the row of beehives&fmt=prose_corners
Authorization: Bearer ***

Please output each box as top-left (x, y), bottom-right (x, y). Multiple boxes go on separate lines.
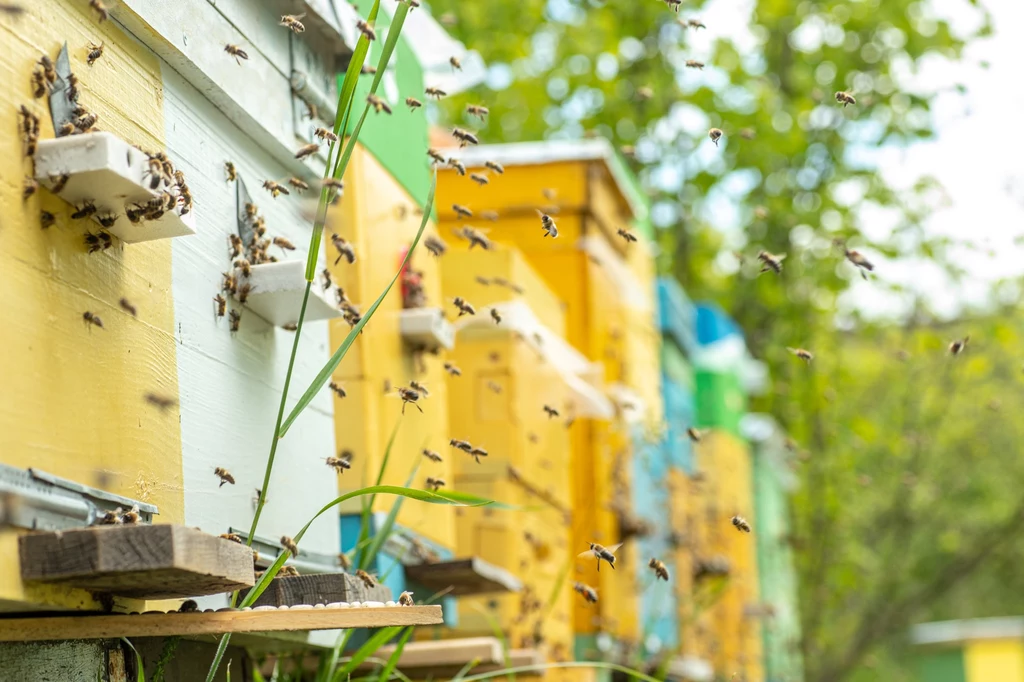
top-left (430, 0), bottom-right (1024, 682)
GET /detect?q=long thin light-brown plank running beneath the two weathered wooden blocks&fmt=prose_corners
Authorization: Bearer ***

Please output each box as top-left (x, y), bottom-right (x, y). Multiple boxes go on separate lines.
top-left (0, 606), bottom-right (442, 642)
